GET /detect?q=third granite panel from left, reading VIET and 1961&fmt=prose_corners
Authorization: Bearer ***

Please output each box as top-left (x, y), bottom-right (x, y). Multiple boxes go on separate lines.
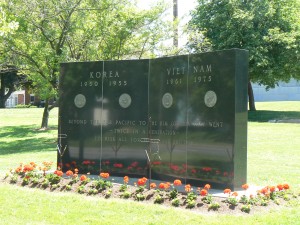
top-left (149, 56), bottom-right (188, 181)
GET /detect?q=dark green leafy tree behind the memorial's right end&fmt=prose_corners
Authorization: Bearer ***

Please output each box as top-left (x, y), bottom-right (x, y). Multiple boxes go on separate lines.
top-left (190, 0), bottom-right (300, 110)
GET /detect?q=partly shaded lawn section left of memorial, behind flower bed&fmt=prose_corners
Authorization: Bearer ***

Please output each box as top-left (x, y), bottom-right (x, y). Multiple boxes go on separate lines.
top-left (0, 108), bottom-right (58, 174)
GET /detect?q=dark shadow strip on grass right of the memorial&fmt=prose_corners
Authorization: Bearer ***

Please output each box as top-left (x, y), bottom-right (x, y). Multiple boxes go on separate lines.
top-left (248, 110), bottom-right (300, 122)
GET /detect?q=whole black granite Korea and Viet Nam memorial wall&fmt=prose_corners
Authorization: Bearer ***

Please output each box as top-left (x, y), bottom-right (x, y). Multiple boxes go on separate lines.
top-left (58, 49), bottom-right (248, 189)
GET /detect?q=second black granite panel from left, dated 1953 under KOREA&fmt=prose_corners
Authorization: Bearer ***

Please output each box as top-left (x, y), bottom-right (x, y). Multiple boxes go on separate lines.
top-left (99, 60), bottom-right (149, 176)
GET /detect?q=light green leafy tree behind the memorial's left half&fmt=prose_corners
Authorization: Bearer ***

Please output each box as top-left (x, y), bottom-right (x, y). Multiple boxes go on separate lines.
top-left (5, 0), bottom-right (172, 128)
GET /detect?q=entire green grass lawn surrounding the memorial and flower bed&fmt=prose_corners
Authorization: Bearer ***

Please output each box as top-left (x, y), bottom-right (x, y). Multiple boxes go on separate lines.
top-left (0, 102), bottom-right (300, 225)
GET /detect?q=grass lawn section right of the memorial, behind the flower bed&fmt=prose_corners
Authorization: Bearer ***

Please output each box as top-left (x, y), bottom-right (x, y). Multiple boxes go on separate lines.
top-left (248, 102), bottom-right (300, 189)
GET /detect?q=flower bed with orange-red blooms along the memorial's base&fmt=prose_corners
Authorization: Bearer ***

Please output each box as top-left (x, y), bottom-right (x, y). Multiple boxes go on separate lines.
top-left (3, 162), bottom-right (300, 213)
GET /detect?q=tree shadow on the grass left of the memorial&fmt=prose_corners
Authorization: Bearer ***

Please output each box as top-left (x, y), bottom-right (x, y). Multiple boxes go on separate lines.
top-left (0, 126), bottom-right (56, 155)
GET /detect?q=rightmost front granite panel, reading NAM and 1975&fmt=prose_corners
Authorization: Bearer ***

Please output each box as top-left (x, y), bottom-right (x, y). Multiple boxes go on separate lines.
top-left (187, 50), bottom-right (246, 188)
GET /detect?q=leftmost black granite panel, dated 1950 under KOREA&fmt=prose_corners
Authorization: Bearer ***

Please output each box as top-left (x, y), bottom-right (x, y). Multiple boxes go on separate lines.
top-left (58, 62), bottom-right (103, 173)
